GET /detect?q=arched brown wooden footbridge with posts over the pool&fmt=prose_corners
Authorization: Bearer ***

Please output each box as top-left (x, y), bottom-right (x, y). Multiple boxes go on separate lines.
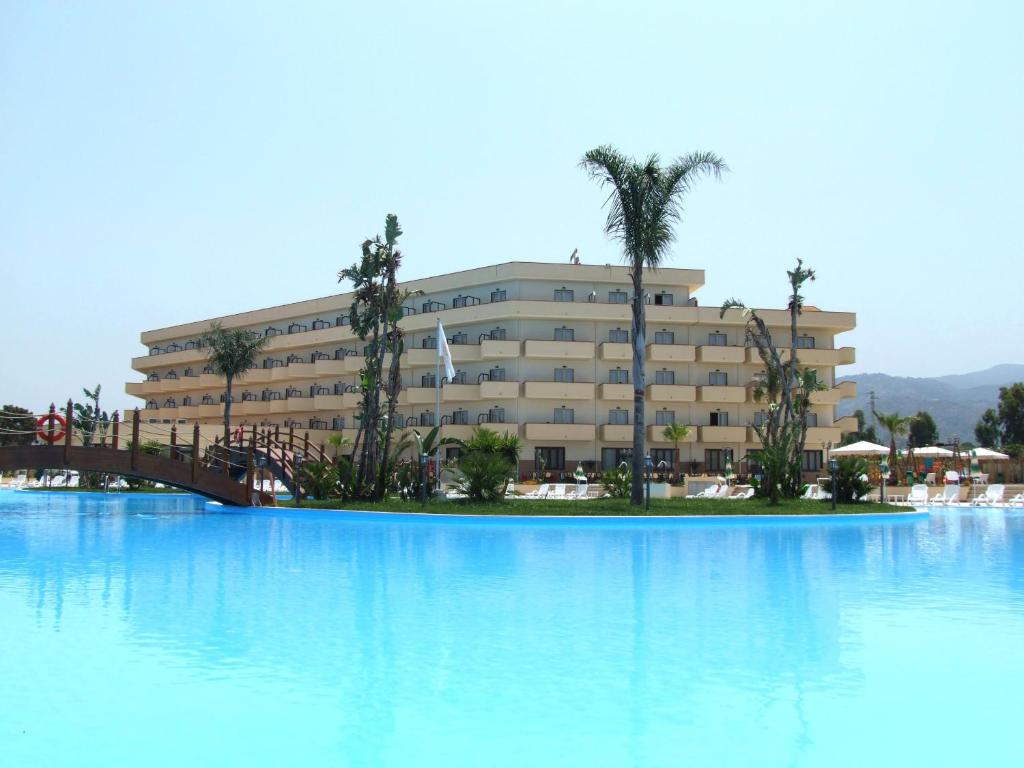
top-left (0, 400), bottom-right (330, 507)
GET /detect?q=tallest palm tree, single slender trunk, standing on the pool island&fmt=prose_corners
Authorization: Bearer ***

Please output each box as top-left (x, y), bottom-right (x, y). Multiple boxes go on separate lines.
top-left (580, 144), bottom-right (728, 505)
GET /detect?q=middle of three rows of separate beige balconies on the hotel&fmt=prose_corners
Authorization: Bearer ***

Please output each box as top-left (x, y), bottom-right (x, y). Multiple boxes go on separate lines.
top-left (132, 378), bottom-right (857, 415)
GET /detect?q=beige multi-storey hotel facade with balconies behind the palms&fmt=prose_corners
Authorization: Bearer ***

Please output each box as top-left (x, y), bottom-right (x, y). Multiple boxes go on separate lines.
top-left (126, 262), bottom-right (856, 479)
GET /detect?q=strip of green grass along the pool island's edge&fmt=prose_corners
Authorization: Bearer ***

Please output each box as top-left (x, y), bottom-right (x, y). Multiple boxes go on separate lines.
top-left (279, 499), bottom-right (909, 516)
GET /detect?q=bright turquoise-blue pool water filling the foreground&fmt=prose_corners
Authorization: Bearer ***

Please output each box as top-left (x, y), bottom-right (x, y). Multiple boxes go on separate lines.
top-left (0, 492), bottom-right (1024, 767)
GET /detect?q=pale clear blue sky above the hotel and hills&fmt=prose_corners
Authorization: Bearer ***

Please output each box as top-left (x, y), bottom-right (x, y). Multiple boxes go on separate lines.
top-left (0, 0), bottom-right (1024, 409)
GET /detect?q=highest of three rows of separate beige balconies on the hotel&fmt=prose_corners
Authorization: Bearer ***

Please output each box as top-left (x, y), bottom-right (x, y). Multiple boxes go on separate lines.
top-left (132, 337), bottom-right (856, 378)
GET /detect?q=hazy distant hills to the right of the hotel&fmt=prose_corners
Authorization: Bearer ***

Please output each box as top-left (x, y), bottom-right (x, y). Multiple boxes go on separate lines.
top-left (837, 364), bottom-right (1024, 441)
